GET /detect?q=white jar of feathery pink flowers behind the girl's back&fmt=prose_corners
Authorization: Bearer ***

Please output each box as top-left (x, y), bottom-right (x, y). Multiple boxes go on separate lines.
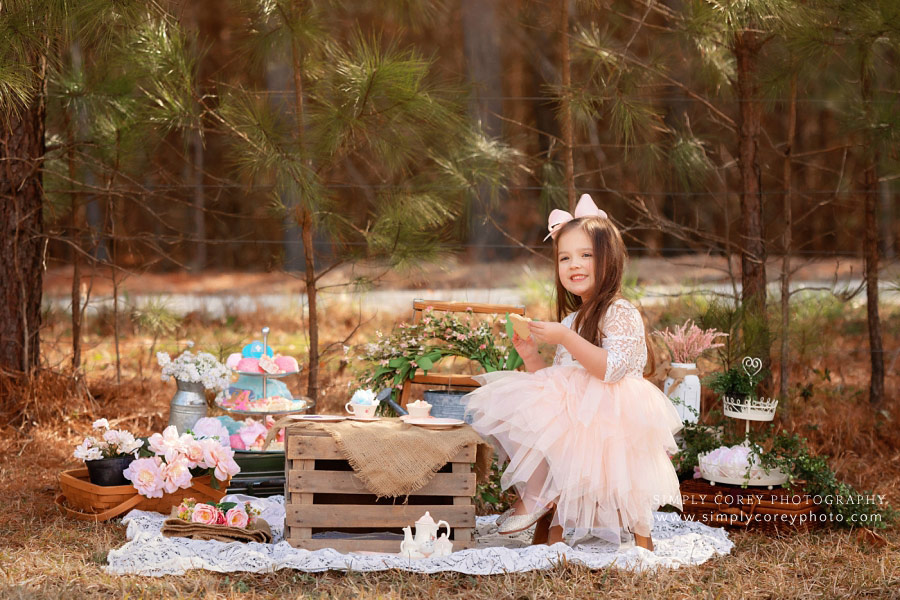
top-left (654, 320), bottom-right (728, 423)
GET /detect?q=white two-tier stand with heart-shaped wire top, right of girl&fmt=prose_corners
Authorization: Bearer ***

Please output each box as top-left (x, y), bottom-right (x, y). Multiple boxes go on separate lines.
top-left (697, 356), bottom-right (788, 490)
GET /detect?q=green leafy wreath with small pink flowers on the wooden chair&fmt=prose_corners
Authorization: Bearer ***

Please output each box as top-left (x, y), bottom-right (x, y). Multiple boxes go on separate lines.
top-left (358, 307), bottom-right (522, 400)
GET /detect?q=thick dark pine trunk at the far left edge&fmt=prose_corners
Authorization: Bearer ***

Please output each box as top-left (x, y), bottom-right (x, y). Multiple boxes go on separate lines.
top-left (0, 93), bottom-right (46, 378)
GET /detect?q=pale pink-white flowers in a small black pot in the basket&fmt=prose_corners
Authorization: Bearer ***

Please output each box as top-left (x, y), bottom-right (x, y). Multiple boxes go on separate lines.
top-left (74, 419), bottom-right (144, 486)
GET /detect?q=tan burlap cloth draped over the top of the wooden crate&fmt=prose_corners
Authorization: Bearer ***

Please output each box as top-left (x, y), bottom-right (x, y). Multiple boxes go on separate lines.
top-left (284, 419), bottom-right (494, 498)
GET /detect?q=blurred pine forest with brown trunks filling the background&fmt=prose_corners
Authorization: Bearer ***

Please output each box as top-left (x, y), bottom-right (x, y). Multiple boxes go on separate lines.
top-left (0, 0), bottom-right (900, 404)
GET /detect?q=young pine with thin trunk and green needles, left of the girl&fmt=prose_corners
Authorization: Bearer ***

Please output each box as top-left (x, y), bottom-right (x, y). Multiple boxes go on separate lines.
top-left (214, 0), bottom-right (516, 398)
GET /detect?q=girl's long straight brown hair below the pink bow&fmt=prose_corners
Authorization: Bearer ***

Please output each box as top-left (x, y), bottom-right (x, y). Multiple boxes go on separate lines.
top-left (553, 217), bottom-right (656, 372)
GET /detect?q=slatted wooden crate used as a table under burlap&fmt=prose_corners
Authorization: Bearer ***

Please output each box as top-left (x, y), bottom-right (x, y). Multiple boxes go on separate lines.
top-left (284, 427), bottom-right (475, 552)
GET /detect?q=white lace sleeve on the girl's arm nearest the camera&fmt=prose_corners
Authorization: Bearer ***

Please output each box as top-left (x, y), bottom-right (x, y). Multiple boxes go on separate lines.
top-left (601, 300), bottom-right (647, 383)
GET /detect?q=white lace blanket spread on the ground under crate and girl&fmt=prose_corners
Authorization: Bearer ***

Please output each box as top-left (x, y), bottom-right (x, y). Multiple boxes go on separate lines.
top-left (106, 494), bottom-right (734, 577)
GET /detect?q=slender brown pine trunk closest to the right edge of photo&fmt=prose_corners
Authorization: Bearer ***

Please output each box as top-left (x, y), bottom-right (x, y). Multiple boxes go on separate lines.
top-left (860, 60), bottom-right (884, 406)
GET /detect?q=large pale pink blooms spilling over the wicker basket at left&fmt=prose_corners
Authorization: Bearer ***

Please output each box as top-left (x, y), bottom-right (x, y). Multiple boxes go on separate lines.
top-left (124, 425), bottom-right (241, 498)
